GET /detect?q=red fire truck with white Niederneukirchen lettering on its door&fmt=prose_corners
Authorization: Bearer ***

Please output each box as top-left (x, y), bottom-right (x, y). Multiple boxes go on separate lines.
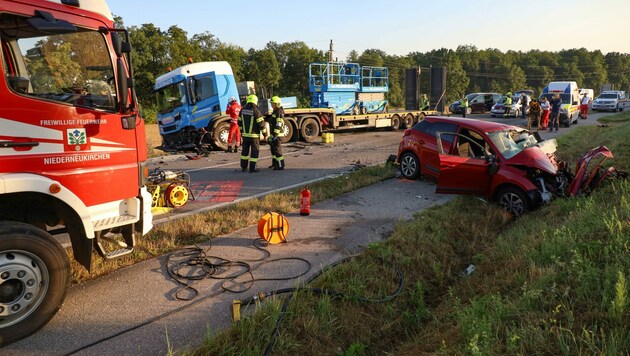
top-left (0, 0), bottom-right (152, 345)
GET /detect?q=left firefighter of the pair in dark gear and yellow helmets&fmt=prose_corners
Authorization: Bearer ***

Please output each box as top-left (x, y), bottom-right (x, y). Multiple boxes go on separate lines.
top-left (239, 94), bottom-right (267, 173)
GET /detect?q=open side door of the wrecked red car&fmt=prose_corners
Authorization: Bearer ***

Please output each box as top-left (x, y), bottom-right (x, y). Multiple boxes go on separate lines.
top-left (435, 132), bottom-right (496, 195)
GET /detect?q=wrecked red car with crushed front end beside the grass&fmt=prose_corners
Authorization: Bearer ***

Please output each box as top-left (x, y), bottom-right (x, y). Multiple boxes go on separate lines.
top-left (397, 116), bottom-right (573, 216)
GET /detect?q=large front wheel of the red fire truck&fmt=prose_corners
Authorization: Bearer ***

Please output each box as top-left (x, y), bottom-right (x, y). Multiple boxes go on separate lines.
top-left (0, 221), bottom-right (70, 346)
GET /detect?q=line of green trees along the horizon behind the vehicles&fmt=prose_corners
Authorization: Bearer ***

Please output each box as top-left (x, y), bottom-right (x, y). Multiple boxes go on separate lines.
top-left (116, 17), bottom-right (630, 120)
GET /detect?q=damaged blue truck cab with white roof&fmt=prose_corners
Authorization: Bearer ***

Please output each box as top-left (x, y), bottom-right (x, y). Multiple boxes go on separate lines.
top-left (153, 62), bottom-right (238, 151)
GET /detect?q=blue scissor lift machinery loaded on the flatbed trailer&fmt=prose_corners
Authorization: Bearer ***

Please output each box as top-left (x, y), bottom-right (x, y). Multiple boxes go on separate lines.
top-left (309, 62), bottom-right (389, 115)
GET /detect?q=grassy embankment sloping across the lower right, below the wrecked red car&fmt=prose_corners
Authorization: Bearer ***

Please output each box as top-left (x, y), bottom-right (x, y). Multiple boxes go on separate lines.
top-left (189, 113), bottom-right (630, 355)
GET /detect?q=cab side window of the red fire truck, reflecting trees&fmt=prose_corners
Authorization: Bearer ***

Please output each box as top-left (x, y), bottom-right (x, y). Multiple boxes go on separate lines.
top-left (1, 15), bottom-right (116, 111)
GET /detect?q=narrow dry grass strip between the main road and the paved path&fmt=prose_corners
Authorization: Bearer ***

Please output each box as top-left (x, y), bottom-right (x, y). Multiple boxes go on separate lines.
top-left (68, 164), bottom-right (396, 283)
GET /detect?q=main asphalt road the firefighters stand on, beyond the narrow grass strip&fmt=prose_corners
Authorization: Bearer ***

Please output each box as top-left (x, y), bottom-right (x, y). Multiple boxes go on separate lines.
top-left (150, 113), bottom-right (604, 224)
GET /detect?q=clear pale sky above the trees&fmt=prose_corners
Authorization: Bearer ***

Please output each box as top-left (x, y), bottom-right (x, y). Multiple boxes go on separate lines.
top-left (107, 0), bottom-right (630, 60)
